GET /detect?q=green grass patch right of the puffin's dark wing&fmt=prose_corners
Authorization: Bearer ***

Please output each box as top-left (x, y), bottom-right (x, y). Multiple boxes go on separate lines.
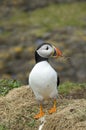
top-left (59, 82), bottom-right (86, 95)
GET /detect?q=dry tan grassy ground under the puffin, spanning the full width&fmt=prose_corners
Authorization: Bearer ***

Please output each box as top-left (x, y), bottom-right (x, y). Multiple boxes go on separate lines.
top-left (0, 86), bottom-right (86, 130)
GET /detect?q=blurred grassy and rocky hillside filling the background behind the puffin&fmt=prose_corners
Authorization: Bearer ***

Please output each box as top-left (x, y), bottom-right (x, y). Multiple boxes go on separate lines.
top-left (0, 0), bottom-right (86, 84)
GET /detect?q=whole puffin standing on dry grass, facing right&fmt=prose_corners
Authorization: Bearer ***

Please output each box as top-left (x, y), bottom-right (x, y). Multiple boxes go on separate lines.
top-left (29, 43), bottom-right (62, 119)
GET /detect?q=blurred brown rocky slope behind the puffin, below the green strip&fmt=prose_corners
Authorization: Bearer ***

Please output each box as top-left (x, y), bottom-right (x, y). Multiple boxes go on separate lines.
top-left (0, 27), bottom-right (86, 82)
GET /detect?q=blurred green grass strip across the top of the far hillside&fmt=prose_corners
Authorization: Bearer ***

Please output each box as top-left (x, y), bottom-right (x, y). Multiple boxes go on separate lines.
top-left (0, 2), bottom-right (86, 36)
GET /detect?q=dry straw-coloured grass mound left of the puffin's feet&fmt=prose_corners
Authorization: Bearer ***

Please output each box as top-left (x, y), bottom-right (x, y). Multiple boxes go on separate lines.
top-left (0, 86), bottom-right (37, 130)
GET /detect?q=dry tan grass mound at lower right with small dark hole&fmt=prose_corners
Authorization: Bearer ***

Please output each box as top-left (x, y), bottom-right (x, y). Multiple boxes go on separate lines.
top-left (42, 99), bottom-right (86, 130)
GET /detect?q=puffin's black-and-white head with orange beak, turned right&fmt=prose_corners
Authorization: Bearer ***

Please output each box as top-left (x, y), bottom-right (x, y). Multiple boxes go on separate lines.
top-left (35, 43), bottom-right (62, 62)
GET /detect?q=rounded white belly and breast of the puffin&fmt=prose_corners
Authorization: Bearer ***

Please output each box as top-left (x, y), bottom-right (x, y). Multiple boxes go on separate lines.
top-left (29, 61), bottom-right (57, 100)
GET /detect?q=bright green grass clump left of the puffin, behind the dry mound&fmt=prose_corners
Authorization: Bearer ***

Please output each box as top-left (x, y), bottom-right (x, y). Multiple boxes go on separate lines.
top-left (0, 79), bottom-right (22, 96)
